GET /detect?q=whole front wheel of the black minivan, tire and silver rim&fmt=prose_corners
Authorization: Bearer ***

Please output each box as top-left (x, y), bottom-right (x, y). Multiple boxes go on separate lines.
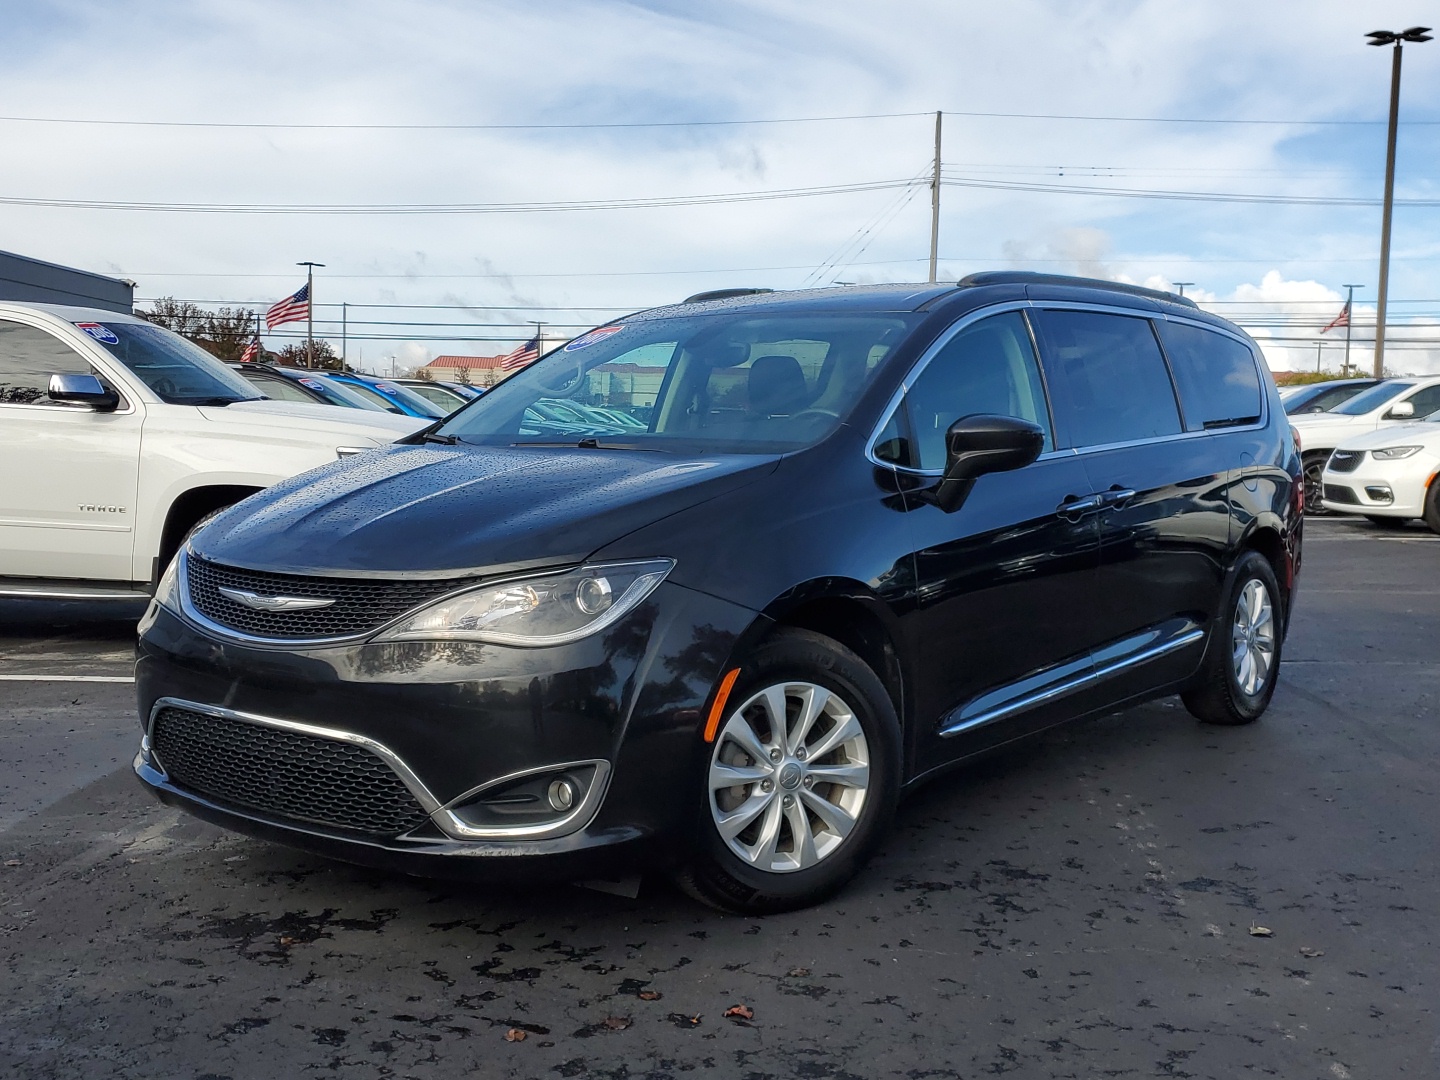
top-left (677, 629), bottom-right (900, 914)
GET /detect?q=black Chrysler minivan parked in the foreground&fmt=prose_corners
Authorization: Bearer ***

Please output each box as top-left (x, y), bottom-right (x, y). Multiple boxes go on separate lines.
top-left (135, 272), bottom-right (1303, 913)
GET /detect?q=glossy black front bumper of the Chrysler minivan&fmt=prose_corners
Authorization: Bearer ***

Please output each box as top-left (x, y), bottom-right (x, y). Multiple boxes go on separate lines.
top-left (135, 583), bottom-right (756, 881)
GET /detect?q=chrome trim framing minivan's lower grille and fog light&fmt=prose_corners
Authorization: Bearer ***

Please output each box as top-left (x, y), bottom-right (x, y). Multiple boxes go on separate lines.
top-left (141, 697), bottom-right (611, 840)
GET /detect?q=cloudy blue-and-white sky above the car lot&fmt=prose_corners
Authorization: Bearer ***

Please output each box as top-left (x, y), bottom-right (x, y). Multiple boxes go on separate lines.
top-left (0, 0), bottom-right (1440, 373)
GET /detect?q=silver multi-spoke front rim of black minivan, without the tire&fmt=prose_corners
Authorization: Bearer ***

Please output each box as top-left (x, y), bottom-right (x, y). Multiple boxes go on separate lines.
top-left (708, 681), bottom-right (870, 874)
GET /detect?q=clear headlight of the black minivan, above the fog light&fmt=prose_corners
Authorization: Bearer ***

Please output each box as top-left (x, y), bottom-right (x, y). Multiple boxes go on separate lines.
top-left (374, 559), bottom-right (675, 648)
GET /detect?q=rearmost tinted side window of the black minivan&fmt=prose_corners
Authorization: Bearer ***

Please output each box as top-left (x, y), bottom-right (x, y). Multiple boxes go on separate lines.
top-left (1156, 323), bottom-right (1264, 431)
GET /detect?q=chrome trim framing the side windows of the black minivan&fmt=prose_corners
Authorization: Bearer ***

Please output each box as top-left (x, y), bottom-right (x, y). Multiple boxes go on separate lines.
top-left (865, 300), bottom-right (1272, 477)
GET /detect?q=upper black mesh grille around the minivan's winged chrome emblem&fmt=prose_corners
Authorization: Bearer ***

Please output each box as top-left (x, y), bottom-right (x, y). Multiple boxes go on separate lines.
top-left (186, 556), bottom-right (481, 641)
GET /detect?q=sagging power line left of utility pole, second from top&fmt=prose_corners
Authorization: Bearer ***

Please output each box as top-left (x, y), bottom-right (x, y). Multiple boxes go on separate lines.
top-left (0, 180), bottom-right (912, 215)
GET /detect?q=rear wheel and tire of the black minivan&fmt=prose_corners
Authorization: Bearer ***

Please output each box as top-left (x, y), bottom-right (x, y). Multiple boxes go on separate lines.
top-left (1181, 552), bottom-right (1284, 726)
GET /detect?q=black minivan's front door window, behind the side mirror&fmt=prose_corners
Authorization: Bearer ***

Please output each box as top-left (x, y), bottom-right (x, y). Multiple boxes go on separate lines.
top-left (876, 311), bottom-right (1054, 472)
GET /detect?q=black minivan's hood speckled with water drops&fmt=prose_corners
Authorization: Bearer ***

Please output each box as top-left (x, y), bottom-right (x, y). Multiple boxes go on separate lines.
top-left (194, 445), bottom-right (779, 576)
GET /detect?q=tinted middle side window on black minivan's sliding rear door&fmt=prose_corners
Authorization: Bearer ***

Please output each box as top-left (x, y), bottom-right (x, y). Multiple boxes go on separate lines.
top-left (1034, 310), bottom-right (1181, 446)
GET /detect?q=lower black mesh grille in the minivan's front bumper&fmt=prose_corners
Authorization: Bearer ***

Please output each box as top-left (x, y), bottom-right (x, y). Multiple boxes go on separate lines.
top-left (150, 706), bottom-right (429, 837)
